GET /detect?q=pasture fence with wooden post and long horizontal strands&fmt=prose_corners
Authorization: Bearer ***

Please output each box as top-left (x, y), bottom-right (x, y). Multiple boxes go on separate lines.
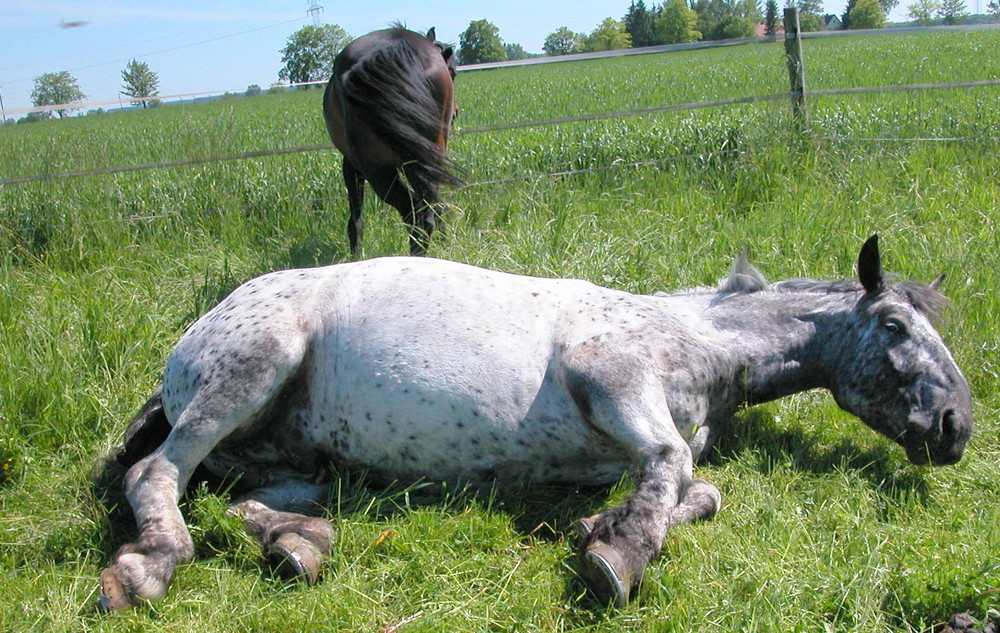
top-left (0, 21), bottom-right (1000, 186)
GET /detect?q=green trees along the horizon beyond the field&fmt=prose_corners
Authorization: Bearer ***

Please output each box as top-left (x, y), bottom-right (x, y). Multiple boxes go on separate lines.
top-left (15, 0), bottom-right (1000, 124)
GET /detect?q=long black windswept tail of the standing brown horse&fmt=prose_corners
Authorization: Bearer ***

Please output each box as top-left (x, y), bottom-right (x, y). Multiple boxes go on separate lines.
top-left (342, 39), bottom-right (462, 189)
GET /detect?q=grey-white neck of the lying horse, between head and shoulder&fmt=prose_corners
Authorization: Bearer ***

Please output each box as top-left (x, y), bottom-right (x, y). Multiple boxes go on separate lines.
top-left (707, 290), bottom-right (857, 404)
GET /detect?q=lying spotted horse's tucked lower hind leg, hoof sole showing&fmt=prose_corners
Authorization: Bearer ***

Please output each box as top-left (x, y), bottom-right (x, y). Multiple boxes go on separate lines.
top-left (229, 478), bottom-right (335, 585)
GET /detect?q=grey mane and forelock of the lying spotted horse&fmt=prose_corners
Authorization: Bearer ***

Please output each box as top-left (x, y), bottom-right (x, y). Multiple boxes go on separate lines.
top-left (714, 251), bottom-right (948, 322)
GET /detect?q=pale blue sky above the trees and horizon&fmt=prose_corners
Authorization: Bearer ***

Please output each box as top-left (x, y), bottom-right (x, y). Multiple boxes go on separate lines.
top-left (0, 0), bottom-right (920, 118)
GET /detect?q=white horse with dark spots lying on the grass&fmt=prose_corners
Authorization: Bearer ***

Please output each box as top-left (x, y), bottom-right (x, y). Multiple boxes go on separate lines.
top-left (101, 237), bottom-right (973, 609)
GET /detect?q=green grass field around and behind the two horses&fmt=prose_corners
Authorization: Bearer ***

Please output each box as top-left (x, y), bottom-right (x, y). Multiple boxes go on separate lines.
top-left (0, 31), bottom-right (1000, 633)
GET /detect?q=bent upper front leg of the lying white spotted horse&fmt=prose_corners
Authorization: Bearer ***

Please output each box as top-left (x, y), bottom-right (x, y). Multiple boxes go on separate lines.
top-left (563, 346), bottom-right (717, 606)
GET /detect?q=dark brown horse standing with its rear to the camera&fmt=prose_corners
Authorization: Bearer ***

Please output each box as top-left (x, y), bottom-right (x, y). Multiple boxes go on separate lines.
top-left (323, 26), bottom-right (461, 256)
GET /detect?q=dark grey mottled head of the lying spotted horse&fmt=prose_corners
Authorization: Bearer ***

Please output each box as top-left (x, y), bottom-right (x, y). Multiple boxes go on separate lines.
top-left (831, 235), bottom-right (973, 465)
